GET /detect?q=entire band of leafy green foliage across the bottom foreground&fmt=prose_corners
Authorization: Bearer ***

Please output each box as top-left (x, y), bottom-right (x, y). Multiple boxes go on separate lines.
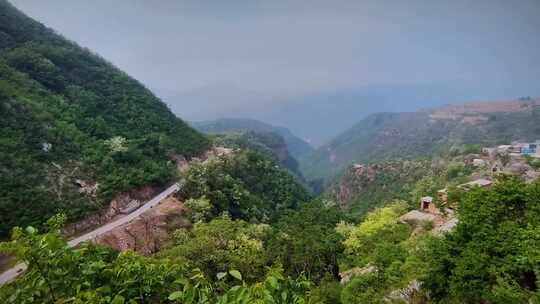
top-left (0, 179), bottom-right (540, 304)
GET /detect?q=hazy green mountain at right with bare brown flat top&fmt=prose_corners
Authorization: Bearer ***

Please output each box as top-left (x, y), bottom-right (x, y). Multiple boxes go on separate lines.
top-left (301, 98), bottom-right (540, 180)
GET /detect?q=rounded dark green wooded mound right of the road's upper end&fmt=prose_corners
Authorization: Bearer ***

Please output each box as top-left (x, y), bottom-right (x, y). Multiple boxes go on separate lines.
top-left (181, 150), bottom-right (310, 222)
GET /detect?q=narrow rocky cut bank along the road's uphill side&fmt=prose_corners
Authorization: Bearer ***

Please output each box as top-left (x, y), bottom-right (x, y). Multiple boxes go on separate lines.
top-left (63, 186), bottom-right (161, 236)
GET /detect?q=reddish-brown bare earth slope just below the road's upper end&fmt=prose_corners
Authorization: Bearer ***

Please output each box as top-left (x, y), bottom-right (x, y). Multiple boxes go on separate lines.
top-left (96, 197), bottom-right (191, 255)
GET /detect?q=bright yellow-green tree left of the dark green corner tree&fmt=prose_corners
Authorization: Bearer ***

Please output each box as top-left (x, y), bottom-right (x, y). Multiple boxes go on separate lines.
top-left (337, 202), bottom-right (429, 304)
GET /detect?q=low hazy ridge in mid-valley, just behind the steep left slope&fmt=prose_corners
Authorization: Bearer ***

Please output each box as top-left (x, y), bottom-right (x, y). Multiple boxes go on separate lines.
top-left (191, 118), bottom-right (314, 159)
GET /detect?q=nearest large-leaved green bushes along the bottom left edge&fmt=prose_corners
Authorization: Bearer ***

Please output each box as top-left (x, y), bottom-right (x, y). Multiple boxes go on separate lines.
top-left (0, 217), bottom-right (310, 304)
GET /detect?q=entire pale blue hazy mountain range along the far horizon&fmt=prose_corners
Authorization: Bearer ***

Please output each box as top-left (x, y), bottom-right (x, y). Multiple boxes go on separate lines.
top-left (167, 83), bottom-right (477, 146)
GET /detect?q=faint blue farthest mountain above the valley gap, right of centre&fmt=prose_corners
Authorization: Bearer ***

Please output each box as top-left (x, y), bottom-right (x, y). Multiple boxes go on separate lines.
top-left (251, 84), bottom-right (470, 146)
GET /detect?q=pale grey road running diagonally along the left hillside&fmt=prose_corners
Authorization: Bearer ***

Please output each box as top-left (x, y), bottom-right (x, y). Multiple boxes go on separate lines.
top-left (0, 183), bottom-right (181, 286)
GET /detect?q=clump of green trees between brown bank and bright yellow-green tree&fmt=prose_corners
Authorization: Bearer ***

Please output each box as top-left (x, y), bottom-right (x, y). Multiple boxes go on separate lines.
top-left (159, 202), bottom-right (343, 282)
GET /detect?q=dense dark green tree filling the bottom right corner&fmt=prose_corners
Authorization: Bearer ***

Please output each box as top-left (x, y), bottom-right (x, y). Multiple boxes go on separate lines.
top-left (423, 178), bottom-right (540, 303)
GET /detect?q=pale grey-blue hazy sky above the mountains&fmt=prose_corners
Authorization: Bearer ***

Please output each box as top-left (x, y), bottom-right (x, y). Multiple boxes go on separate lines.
top-left (11, 0), bottom-right (540, 138)
